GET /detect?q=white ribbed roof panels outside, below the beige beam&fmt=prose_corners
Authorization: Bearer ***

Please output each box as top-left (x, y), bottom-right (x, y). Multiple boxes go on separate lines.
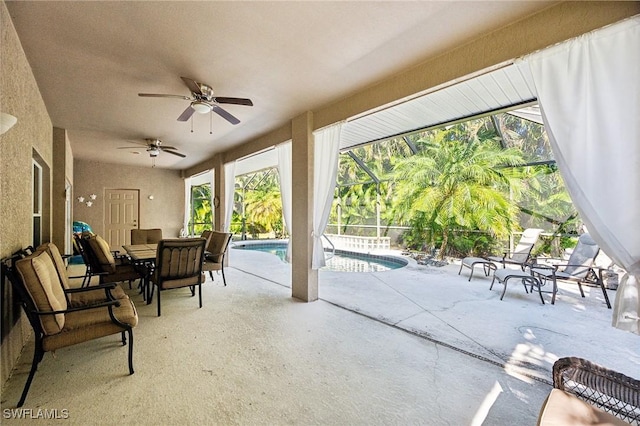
top-left (236, 63), bottom-right (542, 175)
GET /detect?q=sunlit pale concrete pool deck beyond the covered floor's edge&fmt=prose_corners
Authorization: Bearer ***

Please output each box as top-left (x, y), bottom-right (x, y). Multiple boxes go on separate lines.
top-left (229, 243), bottom-right (640, 385)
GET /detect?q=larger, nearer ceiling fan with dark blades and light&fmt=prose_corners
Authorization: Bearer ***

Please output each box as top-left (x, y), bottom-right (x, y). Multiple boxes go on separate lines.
top-left (138, 77), bottom-right (253, 124)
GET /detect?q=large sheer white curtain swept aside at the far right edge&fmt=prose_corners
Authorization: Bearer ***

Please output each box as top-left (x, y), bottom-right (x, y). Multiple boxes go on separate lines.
top-left (521, 15), bottom-right (640, 334)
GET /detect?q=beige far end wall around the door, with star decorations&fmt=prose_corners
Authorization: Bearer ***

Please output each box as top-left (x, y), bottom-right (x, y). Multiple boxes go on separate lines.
top-left (73, 158), bottom-right (184, 238)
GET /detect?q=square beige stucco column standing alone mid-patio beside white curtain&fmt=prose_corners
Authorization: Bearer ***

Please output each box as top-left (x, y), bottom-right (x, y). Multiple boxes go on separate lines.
top-left (291, 112), bottom-right (318, 302)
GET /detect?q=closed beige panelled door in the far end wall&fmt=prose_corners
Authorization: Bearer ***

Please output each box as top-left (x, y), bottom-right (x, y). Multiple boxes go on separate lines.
top-left (104, 189), bottom-right (140, 250)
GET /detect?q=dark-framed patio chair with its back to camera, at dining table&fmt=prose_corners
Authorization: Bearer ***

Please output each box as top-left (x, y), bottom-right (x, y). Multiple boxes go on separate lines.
top-left (147, 238), bottom-right (206, 316)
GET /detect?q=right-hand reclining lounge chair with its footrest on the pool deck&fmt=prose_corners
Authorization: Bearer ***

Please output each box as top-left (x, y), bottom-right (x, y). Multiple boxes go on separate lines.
top-left (531, 233), bottom-right (611, 309)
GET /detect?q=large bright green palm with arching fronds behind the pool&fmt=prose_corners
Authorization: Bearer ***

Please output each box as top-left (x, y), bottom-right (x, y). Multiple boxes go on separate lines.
top-left (395, 120), bottom-right (523, 256)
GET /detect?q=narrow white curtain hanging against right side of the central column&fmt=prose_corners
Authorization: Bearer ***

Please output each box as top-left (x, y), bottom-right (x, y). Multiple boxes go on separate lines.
top-left (311, 123), bottom-right (343, 269)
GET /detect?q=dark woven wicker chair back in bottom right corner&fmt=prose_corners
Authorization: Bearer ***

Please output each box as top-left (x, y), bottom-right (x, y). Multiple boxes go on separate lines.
top-left (553, 357), bottom-right (640, 425)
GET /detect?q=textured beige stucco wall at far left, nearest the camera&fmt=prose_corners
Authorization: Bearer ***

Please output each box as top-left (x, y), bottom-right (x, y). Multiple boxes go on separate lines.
top-left (0, 2), bottom-right (52, 383)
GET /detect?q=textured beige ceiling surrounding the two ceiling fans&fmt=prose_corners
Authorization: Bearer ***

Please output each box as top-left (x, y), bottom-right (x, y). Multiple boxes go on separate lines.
top-left (5, 1), bottom-right (555, 170)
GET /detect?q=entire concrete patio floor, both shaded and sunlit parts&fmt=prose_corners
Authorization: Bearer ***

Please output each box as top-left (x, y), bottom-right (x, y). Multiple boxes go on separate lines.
top-left (2, 246), bottom-right (640, 425)
